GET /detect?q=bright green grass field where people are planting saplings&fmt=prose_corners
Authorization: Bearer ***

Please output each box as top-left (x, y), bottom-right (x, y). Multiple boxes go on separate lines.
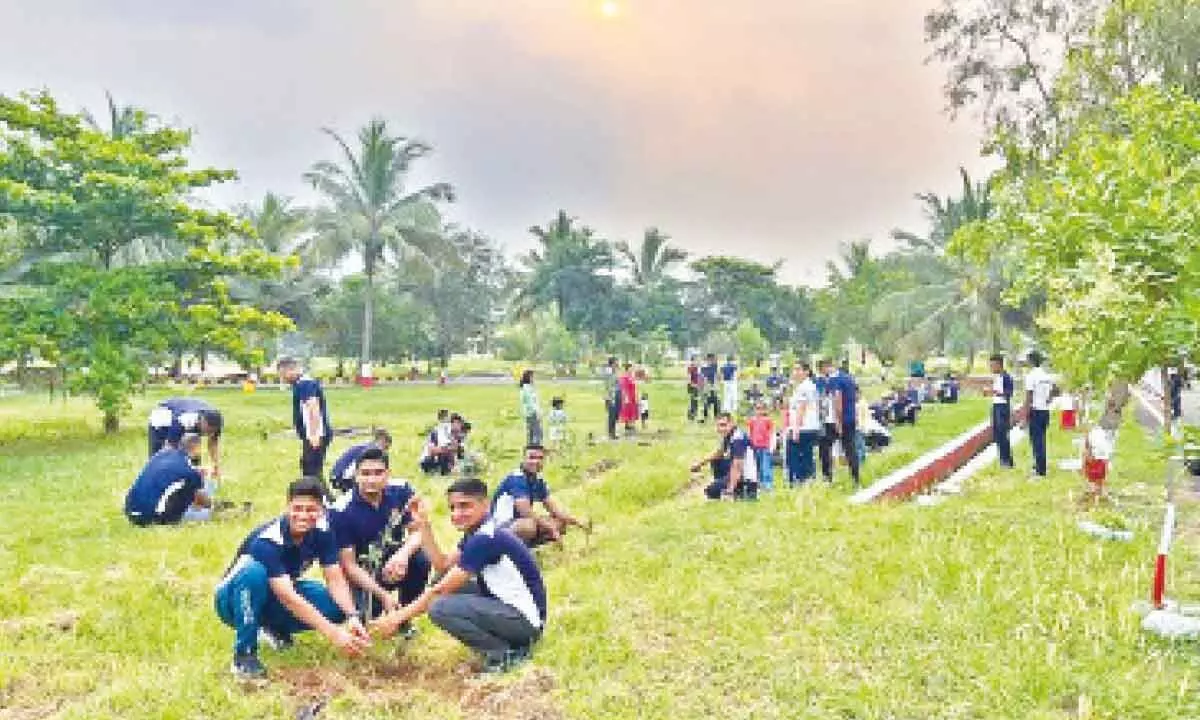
top-left (0, 383), bottom-right (1200, 720)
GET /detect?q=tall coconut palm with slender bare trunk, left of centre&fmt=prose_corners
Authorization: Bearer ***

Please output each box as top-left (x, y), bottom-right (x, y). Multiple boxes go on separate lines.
top-left (305, 119), bottom-right (454, 370)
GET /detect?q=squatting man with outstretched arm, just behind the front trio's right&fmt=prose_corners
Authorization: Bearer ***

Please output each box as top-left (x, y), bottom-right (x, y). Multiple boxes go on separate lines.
top-left (492, 445), bottom-right (590, 547)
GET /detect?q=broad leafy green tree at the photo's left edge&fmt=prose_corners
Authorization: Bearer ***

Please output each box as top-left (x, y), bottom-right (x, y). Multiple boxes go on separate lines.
top-left (0, 92), bottom-right (289, 431)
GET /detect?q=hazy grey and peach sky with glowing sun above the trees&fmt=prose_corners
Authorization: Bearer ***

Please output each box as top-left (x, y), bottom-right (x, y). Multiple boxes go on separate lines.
top-left (0, 0), bottom-right (991, 284)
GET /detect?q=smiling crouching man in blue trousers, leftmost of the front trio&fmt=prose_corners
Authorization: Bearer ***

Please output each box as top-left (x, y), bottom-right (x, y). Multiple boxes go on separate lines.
top-left (215, 478), bottom-right (371, 679)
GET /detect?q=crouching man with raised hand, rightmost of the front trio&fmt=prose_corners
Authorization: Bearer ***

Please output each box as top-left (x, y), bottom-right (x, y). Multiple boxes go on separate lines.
top-left (376, 479), bottom-right (546, 672)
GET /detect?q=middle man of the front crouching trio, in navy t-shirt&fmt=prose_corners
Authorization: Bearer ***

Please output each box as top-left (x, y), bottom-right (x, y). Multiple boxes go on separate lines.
top-left (329, 448), bottom-right (430, 618)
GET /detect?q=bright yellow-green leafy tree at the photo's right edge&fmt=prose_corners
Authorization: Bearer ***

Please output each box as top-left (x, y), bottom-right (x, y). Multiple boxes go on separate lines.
top-left (954, 88), bottom-right (1200, 427)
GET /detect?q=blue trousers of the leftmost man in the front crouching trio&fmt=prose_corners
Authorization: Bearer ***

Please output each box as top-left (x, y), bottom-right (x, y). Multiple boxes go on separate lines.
top-left (214, 560), bottom-right (346, 654)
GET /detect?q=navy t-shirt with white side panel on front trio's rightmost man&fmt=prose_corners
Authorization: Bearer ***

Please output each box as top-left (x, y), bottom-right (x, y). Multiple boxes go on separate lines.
top-left (458, 520), bottom-right (546, 628)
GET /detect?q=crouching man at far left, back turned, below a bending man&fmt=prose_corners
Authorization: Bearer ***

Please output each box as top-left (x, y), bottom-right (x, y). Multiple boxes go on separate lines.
top-left (125, 434), bottom-right (212, 526)
